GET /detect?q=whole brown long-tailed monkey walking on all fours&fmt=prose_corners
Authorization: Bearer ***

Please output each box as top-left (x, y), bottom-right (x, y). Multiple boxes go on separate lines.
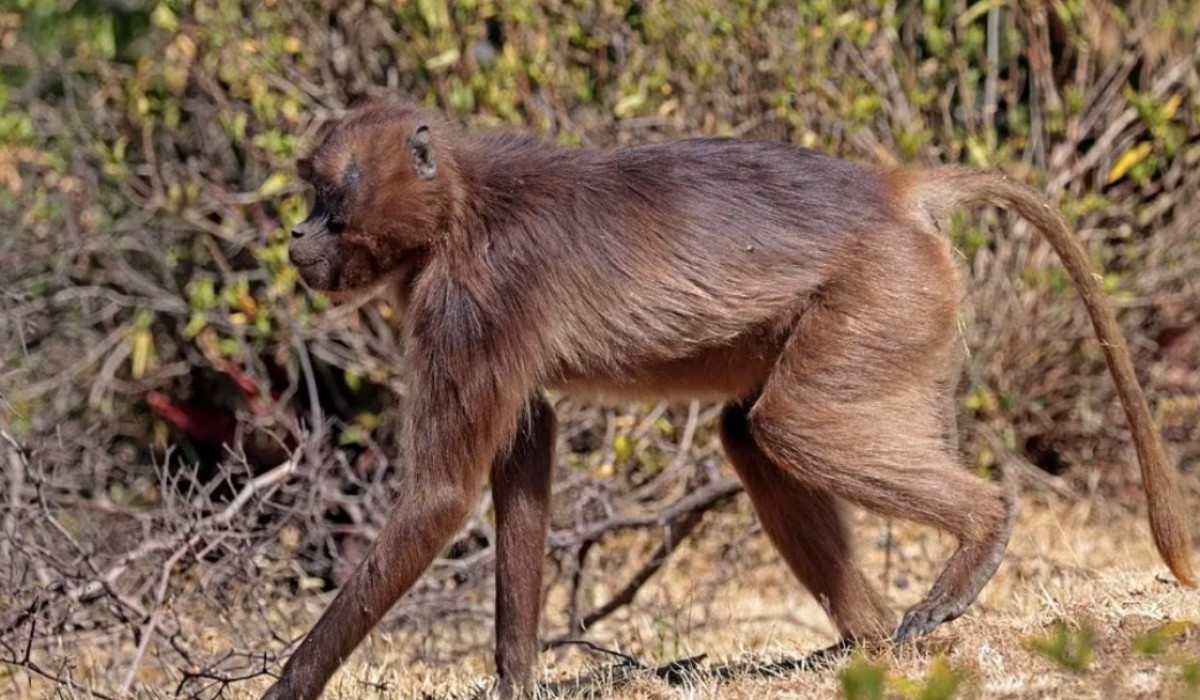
top-left (268, 102), bottom-right (1194, 699)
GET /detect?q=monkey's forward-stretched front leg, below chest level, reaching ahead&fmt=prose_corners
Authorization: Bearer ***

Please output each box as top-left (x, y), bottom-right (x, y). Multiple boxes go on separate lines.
top-left (263, 406), bottom-right (504, 700)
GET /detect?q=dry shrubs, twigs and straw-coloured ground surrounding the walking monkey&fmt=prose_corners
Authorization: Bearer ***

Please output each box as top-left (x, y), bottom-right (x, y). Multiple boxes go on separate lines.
top-left (0, 0), bottom-right (1200, 698)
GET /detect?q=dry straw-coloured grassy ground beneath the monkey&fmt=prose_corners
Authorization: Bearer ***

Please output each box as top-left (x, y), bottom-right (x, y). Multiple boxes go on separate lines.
top-left (0, 487), bottom-right (1200, 700)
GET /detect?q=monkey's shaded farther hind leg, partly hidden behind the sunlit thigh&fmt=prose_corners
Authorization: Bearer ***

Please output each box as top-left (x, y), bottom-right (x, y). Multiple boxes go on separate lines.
top-left (721, 403), bottom-right (895, 641)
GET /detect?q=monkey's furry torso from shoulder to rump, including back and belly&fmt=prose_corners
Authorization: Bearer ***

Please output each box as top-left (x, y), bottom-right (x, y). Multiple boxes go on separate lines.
top-left (453, 138), bottom-right (902, 396)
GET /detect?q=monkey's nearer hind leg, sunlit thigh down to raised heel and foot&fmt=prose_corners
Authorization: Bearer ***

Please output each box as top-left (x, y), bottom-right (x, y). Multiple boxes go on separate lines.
top-left (750, 232), bottom-right (1015, 641)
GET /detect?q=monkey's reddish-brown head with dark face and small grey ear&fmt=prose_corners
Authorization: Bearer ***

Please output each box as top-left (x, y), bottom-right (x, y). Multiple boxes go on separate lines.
top-left (289, 102), bottom-right (458, 292)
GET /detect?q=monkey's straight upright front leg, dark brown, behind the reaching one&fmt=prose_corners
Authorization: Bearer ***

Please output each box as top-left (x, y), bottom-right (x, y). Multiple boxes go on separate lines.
top-left (492, 395), bottom-right (556, 700)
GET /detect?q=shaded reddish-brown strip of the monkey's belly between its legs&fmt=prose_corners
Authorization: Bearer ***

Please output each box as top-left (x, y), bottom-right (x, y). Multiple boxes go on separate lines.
top-left (551, 339), bottom-right (779, 401)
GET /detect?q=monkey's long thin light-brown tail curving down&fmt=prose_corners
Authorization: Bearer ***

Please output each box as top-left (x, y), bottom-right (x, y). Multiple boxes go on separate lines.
top-left (898, 166), bottom-right (1196, 587)
